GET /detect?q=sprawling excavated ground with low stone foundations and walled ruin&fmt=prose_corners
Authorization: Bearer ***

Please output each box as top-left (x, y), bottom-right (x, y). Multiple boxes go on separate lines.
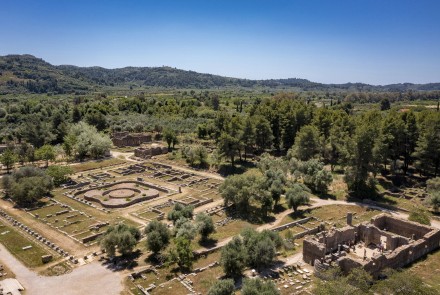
top-left (0, 160), bottom-right (440, 295)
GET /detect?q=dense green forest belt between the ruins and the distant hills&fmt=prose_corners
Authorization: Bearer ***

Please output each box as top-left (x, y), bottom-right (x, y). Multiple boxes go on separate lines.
top-left (0, 85), bottom-right (440, 200)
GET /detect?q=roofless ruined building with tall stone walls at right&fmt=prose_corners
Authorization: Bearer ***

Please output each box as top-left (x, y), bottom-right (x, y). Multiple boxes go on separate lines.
top-left (303, 213), bottom-right (440, 277)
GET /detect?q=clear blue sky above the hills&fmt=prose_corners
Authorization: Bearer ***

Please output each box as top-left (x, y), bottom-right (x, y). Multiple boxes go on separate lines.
top-left (0, 0), bottom-right (440, 85)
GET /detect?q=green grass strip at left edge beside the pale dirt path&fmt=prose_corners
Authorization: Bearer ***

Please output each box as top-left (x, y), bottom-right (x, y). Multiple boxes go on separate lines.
top-left (0, 222), bottom-right (55, 267)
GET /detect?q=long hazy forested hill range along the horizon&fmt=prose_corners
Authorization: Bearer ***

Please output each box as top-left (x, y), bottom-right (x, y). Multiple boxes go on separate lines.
top-left (0, 55), bottom-right (440, 94)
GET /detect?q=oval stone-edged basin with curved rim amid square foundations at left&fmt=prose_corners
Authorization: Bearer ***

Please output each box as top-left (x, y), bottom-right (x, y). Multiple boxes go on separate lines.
top-left (78, 181), bottom-right (159, 208)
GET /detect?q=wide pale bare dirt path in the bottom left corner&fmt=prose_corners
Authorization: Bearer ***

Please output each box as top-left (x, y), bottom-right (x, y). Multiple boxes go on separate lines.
top-left (0, 244), bottom-right (123, 295)
